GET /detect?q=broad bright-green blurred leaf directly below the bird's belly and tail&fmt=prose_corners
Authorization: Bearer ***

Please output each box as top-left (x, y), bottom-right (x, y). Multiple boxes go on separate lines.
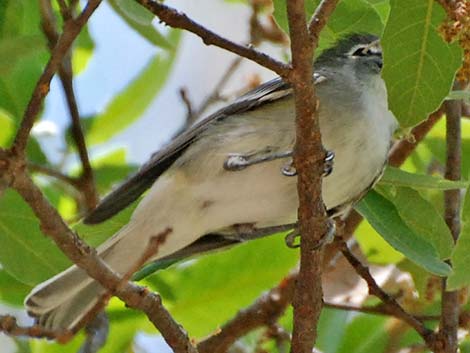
top-left (149, 235), bottom-right (298, 337)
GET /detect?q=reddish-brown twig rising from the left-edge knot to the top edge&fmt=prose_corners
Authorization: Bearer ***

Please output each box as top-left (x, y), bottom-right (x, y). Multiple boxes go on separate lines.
top-left (13, 0), bottom-right (102, 156)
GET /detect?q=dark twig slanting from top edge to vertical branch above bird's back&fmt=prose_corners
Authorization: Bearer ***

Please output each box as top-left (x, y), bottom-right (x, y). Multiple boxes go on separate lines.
top-left (135, 0), bottom-right (290, 77)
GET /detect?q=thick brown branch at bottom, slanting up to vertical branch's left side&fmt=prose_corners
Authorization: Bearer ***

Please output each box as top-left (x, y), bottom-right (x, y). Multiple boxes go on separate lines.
top-left (197, 274), bottom-right (297, 353)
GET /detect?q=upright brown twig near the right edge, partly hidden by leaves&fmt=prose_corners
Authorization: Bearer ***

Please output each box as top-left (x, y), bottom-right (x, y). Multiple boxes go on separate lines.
top-left (438, 84), bottom-right (462, 353)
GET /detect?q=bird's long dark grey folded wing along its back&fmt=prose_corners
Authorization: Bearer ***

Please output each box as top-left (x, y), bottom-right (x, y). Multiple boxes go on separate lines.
top-left (84, 74), bottom-right (323, 224)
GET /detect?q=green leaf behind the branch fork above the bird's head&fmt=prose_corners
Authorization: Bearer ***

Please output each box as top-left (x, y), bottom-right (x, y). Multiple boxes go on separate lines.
top-left (273, 0), bottom-right (383, 50)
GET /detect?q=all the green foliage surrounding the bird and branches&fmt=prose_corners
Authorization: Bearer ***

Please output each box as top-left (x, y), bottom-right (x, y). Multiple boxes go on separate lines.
top-left (0, 0), bottom-right (470, 353)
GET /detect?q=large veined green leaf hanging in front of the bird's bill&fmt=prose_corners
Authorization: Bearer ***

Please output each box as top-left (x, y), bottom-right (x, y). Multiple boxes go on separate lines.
top-left (381, 0), bottom-right (462, 127)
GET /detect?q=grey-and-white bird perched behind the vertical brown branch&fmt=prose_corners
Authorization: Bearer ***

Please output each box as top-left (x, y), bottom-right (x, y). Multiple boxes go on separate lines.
top-left (25, 33), bottom-right (398, 331)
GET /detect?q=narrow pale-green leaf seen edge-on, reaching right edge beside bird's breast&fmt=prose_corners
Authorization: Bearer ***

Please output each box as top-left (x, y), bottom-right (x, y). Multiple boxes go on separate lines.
top-left (379, 167), bottom-right (469, 190)
